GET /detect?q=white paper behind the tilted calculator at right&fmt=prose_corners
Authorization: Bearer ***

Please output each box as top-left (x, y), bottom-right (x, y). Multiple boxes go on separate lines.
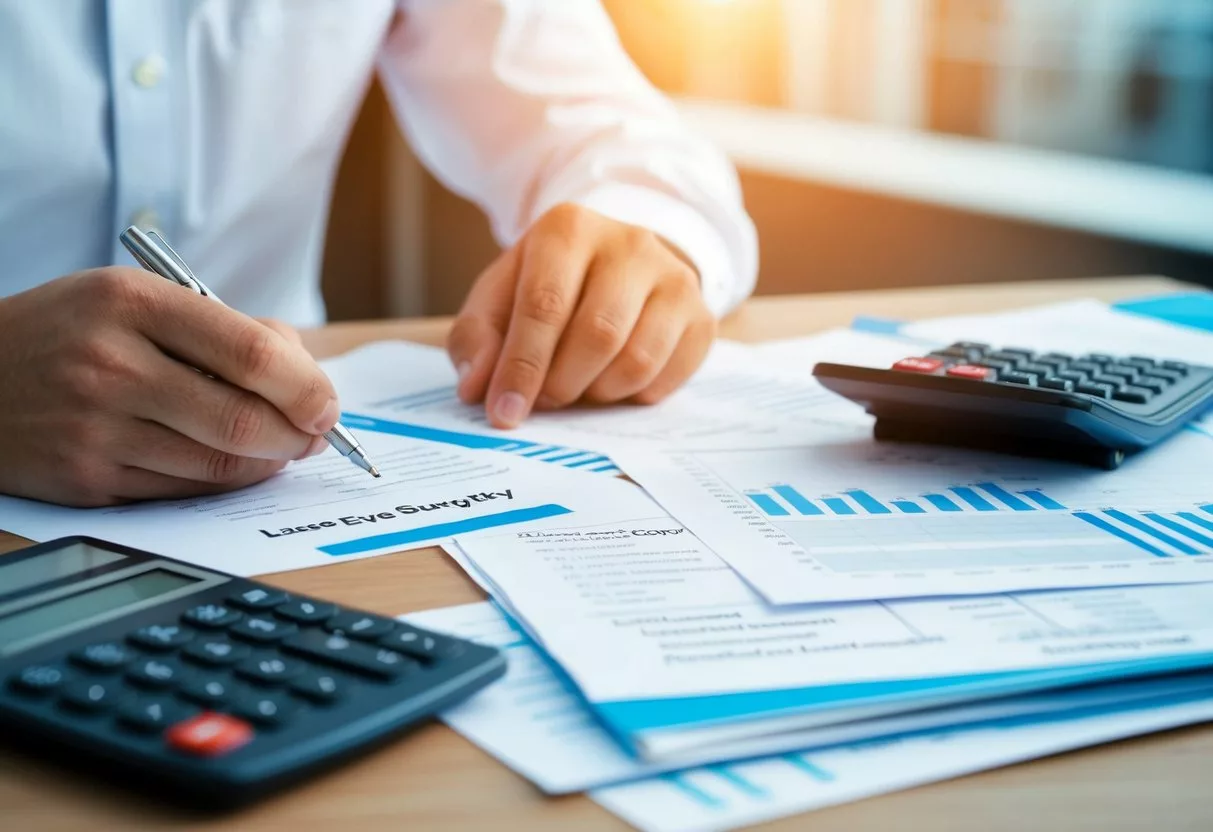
top-left (900, 300), bottom-right (1213, 365)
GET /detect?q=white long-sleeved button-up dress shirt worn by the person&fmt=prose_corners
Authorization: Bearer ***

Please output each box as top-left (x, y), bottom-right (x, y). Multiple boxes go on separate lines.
top-left (0, 0), bottom-right (757, 325)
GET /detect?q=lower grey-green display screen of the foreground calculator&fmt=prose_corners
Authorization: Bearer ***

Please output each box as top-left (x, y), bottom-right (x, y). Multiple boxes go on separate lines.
top-left (0, 569), bottom-right (201, 655)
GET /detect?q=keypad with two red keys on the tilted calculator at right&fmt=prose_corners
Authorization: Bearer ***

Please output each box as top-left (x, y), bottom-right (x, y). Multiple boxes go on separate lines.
top-left (893, 341), bottom-right (1191, 405)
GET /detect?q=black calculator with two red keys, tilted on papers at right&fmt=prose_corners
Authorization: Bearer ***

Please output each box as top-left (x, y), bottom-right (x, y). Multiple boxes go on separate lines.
top-left (813, 341), bottom-right (1213, 469)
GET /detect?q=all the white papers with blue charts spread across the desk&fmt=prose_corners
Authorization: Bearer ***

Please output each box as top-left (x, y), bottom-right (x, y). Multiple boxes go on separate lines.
top-left (0, 302), bottom-right (1213, 831)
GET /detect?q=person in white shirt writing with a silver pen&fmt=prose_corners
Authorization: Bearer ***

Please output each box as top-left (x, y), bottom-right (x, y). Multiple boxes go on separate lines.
top-left (0, 0), bottom-right (757, 506)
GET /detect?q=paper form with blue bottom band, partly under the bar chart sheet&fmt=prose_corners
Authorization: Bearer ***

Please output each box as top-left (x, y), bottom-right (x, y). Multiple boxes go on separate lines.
top-left (456, 517), bottom-right (1213, 759)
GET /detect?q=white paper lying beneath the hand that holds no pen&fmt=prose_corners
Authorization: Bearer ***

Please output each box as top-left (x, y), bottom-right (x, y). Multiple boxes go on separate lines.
top-left (326, 330), bottom-right (912, 458)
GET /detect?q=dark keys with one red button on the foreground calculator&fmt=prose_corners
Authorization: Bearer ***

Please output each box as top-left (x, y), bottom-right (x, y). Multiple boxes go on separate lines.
top-left (7, 587), bottom-right (477, 757)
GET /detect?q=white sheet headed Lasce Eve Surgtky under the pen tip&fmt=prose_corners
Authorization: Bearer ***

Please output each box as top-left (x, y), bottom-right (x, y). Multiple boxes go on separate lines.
top-left (0, 429), bottom-right (651, 575)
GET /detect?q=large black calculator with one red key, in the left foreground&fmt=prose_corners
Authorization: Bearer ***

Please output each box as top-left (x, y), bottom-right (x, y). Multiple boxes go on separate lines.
top-left (0, 537), bottom-right (506, 809)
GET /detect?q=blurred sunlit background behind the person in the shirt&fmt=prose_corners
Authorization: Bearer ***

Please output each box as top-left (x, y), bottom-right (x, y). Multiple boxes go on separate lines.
top-left (325, 0), bottom-right (1213, 320)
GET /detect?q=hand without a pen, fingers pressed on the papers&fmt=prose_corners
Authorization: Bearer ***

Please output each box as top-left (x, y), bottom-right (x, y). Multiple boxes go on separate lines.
top-left (448, 205), bottom-right (716, 428)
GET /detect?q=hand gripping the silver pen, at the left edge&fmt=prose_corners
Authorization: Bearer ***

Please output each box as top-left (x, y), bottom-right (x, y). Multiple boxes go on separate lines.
top-left (0, 267), bottom-right (338, 506)
